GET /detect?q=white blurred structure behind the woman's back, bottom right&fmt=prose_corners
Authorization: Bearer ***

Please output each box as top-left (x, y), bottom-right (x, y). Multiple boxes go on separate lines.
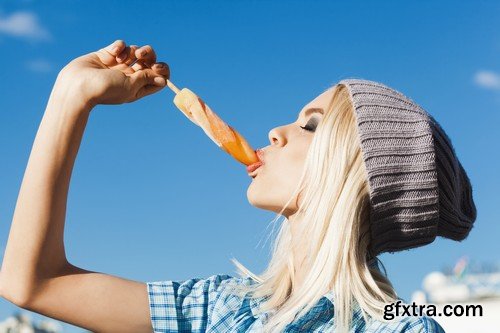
top-left (412, 257), bottom-right (500, 333)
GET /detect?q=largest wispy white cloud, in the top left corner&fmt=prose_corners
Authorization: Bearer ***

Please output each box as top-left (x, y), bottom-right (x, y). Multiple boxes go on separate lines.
top-left (0, 12), bottom-right (51, 40)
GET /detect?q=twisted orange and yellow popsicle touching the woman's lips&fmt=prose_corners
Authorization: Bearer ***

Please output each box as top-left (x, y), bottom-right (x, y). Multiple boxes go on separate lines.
top-left (167, 80), bottom-right (259, 166)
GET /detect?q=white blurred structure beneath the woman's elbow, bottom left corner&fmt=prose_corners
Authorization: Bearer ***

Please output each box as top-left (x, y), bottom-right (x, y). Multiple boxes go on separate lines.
top-left (0, 314), bottom-right (62, 333)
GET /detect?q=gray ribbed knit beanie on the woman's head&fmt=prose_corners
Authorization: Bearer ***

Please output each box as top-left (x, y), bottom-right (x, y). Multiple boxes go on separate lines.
top-left (338, 79), bottom-right (476, 256)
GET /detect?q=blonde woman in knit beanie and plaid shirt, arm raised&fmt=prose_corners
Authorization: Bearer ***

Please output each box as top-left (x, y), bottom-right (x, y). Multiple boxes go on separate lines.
top-left (0, 40), bottom-right (476, 333)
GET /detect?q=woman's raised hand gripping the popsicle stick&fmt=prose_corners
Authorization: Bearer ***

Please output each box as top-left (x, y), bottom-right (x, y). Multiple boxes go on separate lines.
top-left (56, 40), bottom-right (170, 109)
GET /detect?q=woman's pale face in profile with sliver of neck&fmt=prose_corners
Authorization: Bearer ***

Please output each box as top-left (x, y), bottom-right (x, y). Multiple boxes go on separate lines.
top-left (247, 88), bottom-right (333, 284)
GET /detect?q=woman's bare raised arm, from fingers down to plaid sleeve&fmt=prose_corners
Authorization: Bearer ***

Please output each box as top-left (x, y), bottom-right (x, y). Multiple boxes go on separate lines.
top-left (0, 40), bottom-right (169, 333)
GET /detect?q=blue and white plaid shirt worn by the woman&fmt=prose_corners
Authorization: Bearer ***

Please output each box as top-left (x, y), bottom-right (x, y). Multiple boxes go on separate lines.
top-left (147, 262), bottom-right (444, 333)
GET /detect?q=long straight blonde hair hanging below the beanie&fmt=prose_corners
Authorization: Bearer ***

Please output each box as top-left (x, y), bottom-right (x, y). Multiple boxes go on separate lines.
top-left (231, 85), bottom-right (397, 332)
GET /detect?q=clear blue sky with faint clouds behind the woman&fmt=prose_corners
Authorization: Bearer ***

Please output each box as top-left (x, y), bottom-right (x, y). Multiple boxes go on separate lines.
top-left (0, 0), bottom-right (500, 332)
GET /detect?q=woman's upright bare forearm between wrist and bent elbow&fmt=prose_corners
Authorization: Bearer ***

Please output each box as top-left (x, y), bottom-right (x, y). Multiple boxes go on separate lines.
top-left (1, 77), bottom-right (91, 296)
